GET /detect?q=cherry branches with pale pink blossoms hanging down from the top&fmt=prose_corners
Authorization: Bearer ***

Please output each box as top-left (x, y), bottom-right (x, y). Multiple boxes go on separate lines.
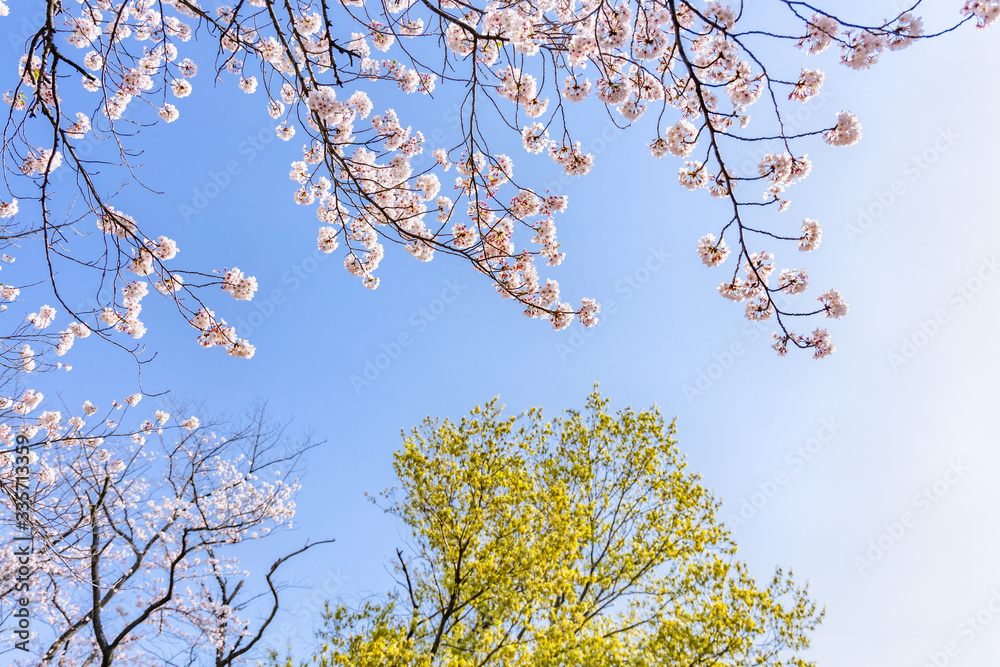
top-left (0, 0), bottom-right (1000, 366)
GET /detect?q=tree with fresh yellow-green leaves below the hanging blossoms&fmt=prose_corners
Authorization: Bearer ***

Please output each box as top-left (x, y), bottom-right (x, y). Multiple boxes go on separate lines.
top-left (276, 388), bottom-right (823, 667)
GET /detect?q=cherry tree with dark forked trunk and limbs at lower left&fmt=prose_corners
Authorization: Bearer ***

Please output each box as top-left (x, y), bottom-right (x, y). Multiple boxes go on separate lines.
top-left (0, 390), bottom-right (321, 667)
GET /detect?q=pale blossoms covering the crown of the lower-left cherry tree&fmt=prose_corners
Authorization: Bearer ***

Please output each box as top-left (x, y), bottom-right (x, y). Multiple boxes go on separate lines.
top-left (0, 382), bottom-right (300, 665)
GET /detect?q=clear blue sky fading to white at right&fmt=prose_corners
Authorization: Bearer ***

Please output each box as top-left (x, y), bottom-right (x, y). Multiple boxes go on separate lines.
top-left (7, 0), bottom-right (1000, 667)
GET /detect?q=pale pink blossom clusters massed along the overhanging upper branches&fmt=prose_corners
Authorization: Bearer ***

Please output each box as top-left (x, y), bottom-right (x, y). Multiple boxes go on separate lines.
top-left (0, 0), bottom-right (984, 356)
